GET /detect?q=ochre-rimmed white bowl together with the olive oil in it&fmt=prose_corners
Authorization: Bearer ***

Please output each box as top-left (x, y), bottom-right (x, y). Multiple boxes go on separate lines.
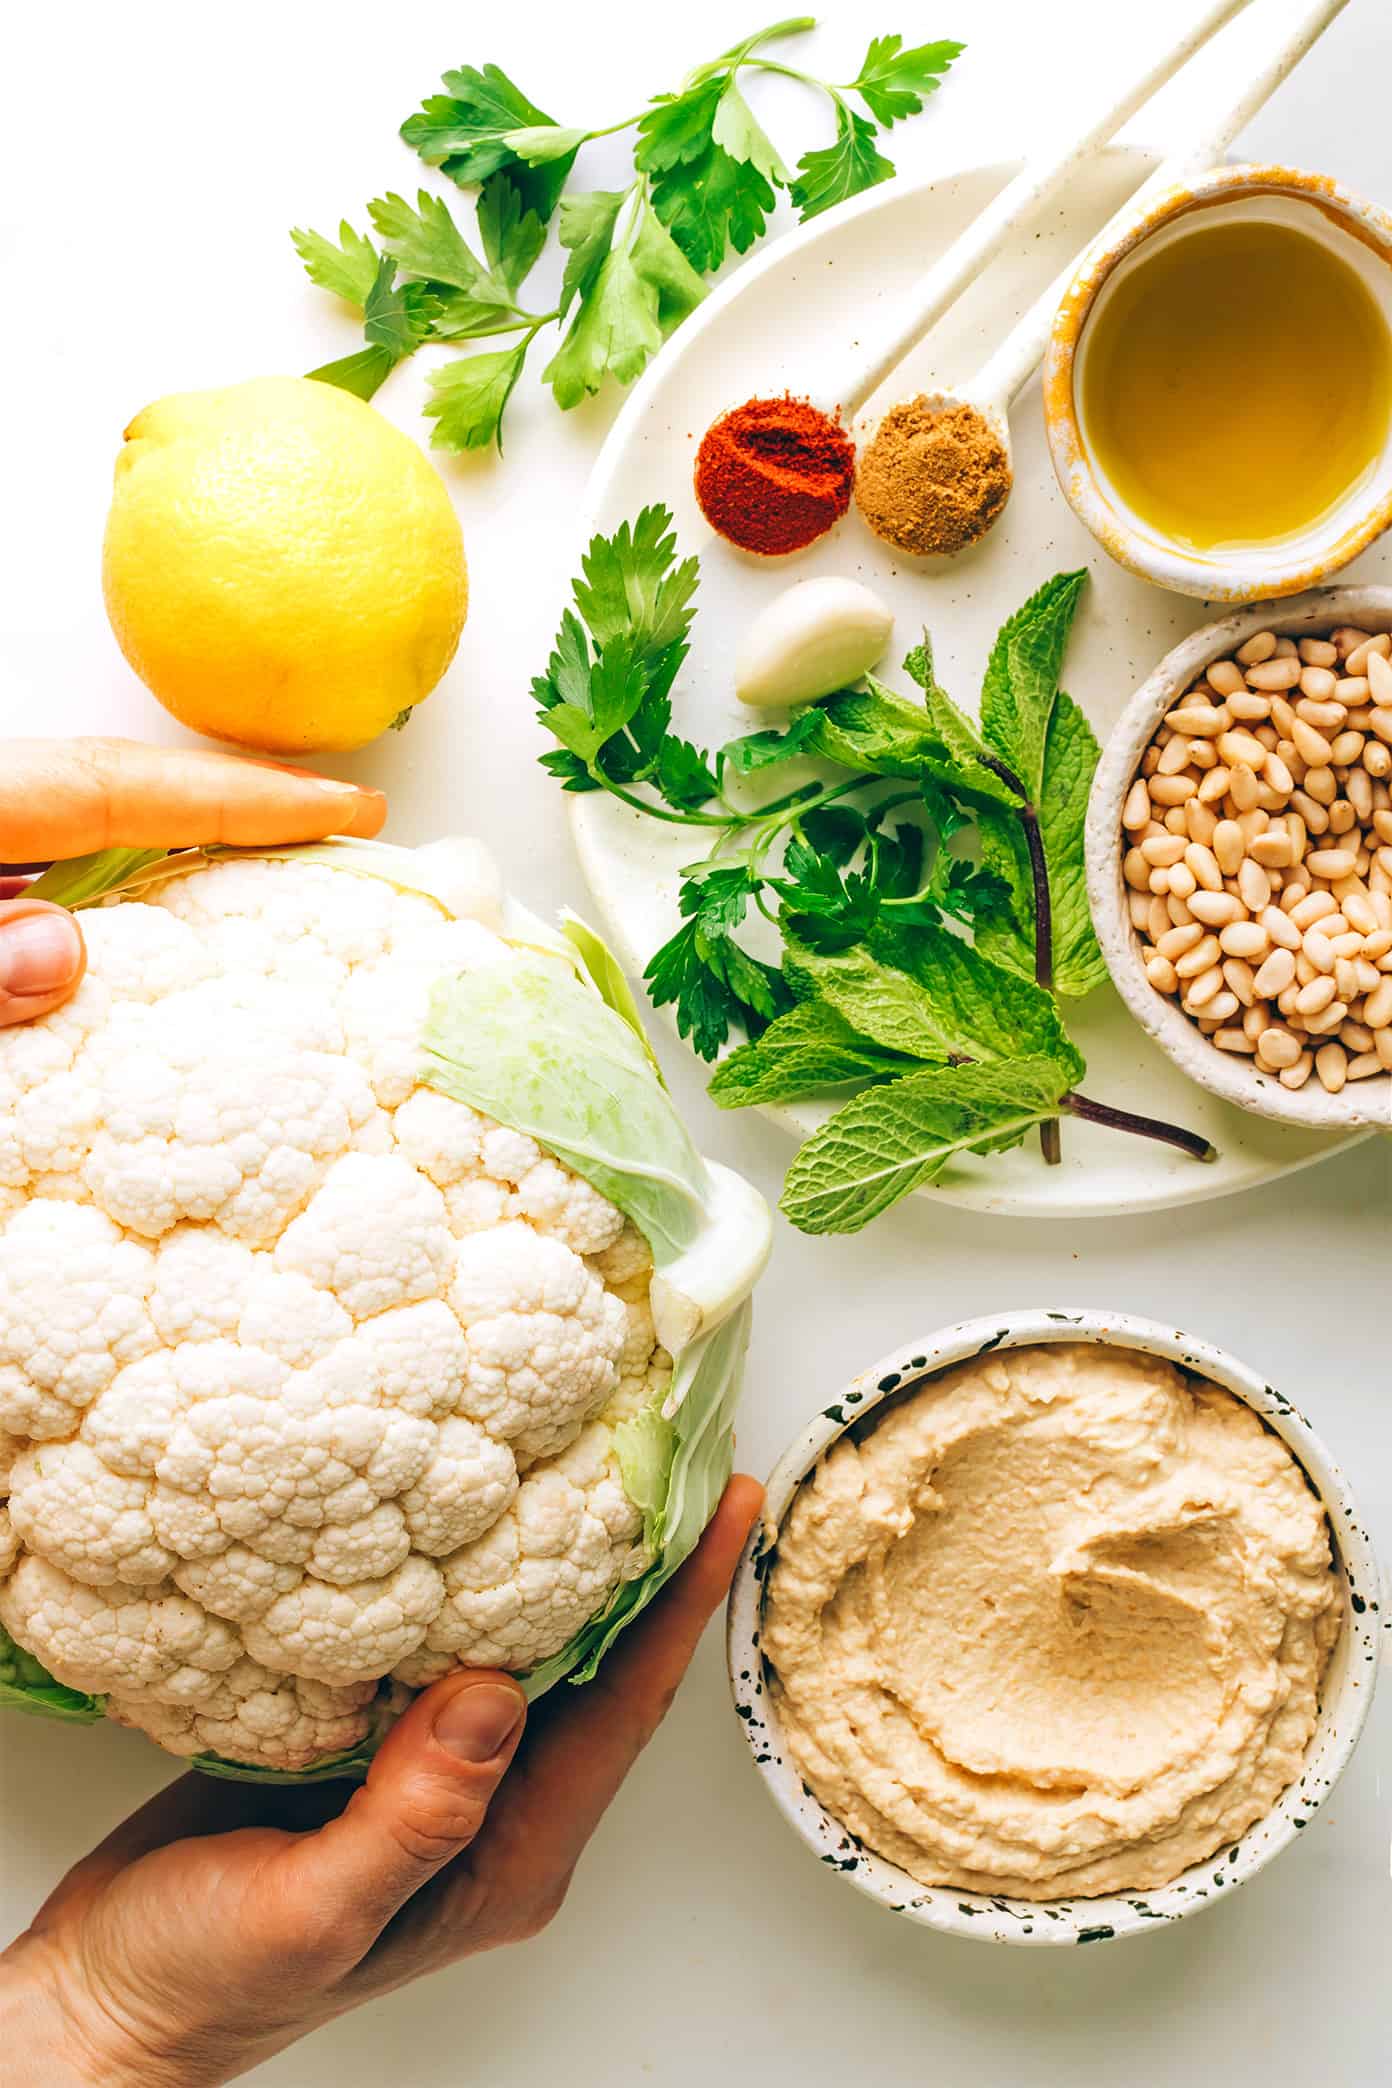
top-left (1043, 167), bottom-right (1392, 601)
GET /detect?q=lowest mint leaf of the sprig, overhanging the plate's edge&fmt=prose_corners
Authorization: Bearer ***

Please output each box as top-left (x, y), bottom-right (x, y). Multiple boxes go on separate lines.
top-left (778, 1059), bottom-right (1069, 1234)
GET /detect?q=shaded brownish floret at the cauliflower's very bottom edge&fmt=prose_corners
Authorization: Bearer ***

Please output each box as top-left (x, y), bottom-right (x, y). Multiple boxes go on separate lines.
top-left (106, 1660), bottom-right (376, 1769)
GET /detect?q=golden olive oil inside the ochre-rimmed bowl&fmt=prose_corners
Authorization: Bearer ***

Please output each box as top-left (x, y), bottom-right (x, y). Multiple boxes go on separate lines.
top-left (1081, 217), bottom-right (1392, 551)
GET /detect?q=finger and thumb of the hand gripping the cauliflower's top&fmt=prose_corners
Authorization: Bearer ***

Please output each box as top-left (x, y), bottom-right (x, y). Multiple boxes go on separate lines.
top-left (0, 739), bottom-right (386, 1027)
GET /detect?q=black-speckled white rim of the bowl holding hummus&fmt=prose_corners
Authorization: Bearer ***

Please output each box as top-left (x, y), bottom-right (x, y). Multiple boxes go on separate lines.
top-left (728, 1309), bottom-right (1379, 1944)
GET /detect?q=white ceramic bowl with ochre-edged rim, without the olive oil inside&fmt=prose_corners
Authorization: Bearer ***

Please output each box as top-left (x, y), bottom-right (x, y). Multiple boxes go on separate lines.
top-left (1043, 167), bottom-right (1392, 601)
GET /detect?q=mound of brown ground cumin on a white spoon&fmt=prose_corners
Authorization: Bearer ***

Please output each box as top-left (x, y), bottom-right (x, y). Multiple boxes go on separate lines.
top-left (856, 395), bottom-right (1010, 553)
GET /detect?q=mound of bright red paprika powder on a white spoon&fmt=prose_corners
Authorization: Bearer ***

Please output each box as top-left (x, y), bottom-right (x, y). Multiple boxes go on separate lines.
top-left (695, 397), bottom-right (856, 557)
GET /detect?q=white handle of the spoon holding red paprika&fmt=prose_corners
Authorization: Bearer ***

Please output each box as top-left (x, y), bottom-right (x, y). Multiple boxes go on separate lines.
top-left (820, 0), bottom-right (1248, 420)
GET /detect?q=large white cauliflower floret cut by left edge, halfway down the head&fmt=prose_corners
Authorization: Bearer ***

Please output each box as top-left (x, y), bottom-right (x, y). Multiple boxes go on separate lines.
top-left (0, 1201), bottom-right (159, 1437)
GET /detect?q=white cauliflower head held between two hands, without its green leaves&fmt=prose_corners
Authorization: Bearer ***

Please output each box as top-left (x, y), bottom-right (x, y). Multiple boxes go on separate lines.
top-left (0, 846), bottom-right (762, 1775)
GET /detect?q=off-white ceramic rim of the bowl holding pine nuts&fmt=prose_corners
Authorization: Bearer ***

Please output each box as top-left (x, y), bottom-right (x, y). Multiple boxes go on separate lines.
top-left (1087, 587), bottom-right (1392, 1132)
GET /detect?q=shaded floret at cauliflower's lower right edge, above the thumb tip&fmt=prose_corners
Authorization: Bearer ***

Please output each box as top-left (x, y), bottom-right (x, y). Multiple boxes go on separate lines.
top-left (397, 1424), bottom-right (647, 1685)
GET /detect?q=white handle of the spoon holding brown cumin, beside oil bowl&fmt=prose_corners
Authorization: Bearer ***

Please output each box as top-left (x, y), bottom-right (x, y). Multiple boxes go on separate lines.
top-left (960, 0), bottom-right (1348, 420)
